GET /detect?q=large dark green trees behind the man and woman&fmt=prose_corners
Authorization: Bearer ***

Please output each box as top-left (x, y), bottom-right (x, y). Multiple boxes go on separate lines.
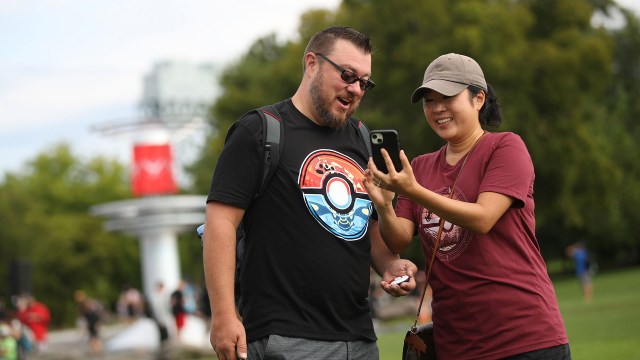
top-left (188, 0), bottom-right (640, 261)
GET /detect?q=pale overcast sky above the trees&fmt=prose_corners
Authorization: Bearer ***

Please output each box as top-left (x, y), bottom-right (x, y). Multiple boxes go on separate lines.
top-left (0, 0), bottom-right (640, 178)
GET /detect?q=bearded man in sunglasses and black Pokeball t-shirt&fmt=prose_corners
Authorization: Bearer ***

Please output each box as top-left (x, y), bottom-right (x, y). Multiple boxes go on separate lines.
top-left (203, 27), bottom-right (417, 360)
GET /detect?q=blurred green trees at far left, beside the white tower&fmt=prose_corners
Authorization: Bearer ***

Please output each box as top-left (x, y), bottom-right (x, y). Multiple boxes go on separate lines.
top-left (0, 144), bottom-right (140, 325)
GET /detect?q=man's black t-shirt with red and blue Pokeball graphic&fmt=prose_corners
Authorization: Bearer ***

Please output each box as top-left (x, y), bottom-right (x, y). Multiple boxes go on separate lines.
top-left (208, 99), bottom-right (376, 341)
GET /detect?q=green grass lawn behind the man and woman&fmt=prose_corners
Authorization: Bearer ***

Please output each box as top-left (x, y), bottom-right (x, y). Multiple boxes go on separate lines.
top-left (378, 268), bottom-right (640, 360)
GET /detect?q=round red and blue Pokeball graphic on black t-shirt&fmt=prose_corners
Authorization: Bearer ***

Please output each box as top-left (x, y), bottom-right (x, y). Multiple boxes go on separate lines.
top-left (298, 150), bottom-right (372, 241)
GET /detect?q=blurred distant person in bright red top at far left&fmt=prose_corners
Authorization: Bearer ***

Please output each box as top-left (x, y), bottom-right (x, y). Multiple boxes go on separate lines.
top-left (16, 294), bottom-right (51, 351)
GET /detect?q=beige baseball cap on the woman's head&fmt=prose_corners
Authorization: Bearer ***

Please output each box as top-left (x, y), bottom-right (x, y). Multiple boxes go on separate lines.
top-left (411, 53), bottom-right (487, 103)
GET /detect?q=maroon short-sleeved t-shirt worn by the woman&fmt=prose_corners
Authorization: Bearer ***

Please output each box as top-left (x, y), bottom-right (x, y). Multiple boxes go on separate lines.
top-left (396, 132), bottom-right (568, 360)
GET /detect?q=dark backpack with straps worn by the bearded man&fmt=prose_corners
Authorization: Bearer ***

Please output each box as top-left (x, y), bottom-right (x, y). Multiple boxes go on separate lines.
top-left (197, 105), bottom-right (371, 307)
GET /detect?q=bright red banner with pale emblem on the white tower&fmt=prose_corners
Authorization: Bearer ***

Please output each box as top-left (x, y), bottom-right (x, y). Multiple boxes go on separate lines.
top-left (131, 144), bottom-right (178, 196)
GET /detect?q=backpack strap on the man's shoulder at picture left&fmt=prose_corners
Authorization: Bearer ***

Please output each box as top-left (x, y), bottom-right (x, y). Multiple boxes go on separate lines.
top-left (256, 105), bottom-right (284, 198)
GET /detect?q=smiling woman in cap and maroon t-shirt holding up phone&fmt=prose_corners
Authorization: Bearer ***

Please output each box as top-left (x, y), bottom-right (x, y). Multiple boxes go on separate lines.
top-left (365, 54), bottom-right (571, 359)
